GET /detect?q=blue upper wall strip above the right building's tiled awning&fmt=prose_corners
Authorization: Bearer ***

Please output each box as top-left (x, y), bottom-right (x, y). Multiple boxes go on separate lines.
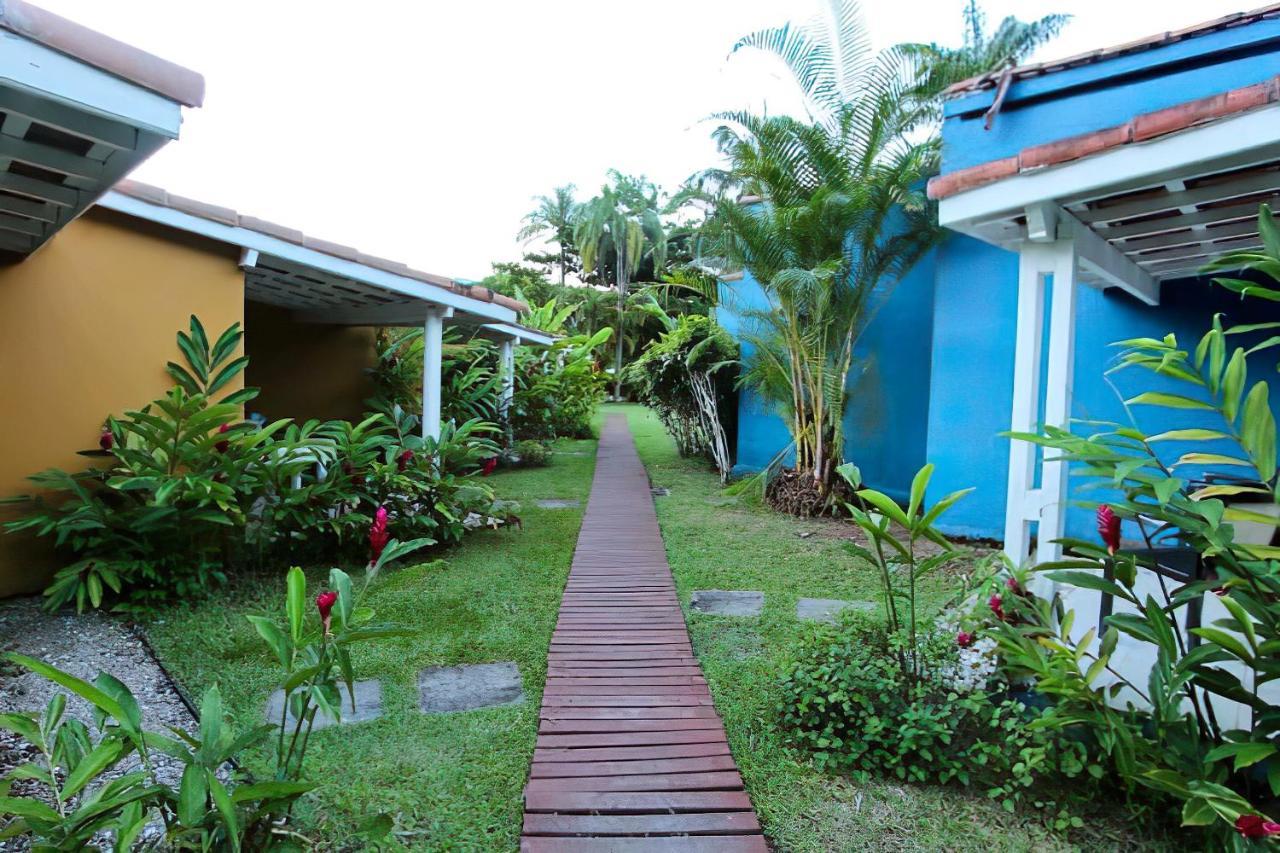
top-left (942, 18), bottom-right (1280, 173)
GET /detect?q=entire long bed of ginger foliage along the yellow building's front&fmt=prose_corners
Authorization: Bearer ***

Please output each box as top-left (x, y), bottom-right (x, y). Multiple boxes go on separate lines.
top-left (5, 318), bottom-right (502, 610)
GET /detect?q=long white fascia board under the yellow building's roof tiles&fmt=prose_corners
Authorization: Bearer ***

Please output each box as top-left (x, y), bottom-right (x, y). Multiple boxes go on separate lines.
top-left (97, 190), bottom-right (520, 323)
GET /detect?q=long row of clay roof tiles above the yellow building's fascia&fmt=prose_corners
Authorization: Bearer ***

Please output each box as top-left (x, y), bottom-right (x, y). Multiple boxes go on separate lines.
top-left (111, 181), bottom-right (529, 314)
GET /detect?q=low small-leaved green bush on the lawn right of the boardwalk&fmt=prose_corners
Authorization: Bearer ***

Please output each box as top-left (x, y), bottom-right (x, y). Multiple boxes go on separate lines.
top-left (782, 614), bottom-right (1102, 811)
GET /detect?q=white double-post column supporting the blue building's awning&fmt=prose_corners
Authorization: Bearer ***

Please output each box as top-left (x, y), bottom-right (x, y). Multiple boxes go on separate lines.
top-left (1005, 238), bottom-right (1076, 564)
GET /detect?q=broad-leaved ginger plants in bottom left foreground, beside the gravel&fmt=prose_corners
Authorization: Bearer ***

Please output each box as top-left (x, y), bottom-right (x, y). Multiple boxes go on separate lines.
top-left (0, 535), bottom-right (428, 852)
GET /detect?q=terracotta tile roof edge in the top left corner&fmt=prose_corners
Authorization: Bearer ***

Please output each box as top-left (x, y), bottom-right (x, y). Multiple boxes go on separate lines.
top-left (0, 0), bottom-right (205, 106)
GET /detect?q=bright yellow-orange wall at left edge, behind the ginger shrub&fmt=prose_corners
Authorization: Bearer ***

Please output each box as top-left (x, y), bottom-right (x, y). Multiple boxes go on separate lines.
top-left (0, 209), bottom-right (244, 596)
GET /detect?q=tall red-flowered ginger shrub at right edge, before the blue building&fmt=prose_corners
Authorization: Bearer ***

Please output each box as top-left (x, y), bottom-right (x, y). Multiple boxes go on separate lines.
top-left (992, 207), bottom-right (1280, 849)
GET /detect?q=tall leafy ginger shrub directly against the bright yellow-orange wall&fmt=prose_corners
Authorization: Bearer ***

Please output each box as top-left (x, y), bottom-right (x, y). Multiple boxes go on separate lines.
top-left (5, 316), bottom-right (306, 608)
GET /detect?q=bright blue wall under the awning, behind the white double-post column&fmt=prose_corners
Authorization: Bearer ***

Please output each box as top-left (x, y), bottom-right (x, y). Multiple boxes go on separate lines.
top-left (928, 236), bottom-right (1280, 539)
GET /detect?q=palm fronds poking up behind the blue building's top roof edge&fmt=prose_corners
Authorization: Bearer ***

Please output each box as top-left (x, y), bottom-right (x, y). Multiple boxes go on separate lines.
top-left (899, 0), bottom-right (1071, 119)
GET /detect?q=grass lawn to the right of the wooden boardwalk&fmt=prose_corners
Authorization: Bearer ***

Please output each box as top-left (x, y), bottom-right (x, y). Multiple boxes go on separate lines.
top-left (608, 406), bottom-right (1152, 852)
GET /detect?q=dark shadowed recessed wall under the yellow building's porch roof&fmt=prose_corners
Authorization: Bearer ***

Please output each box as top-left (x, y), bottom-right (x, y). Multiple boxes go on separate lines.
top-left (244, 302), bottom-right (375, 423)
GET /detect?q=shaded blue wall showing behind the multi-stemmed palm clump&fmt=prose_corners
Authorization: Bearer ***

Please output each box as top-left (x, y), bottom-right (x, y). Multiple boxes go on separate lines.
top-left (718, 245), bottom-right (936, 498)
